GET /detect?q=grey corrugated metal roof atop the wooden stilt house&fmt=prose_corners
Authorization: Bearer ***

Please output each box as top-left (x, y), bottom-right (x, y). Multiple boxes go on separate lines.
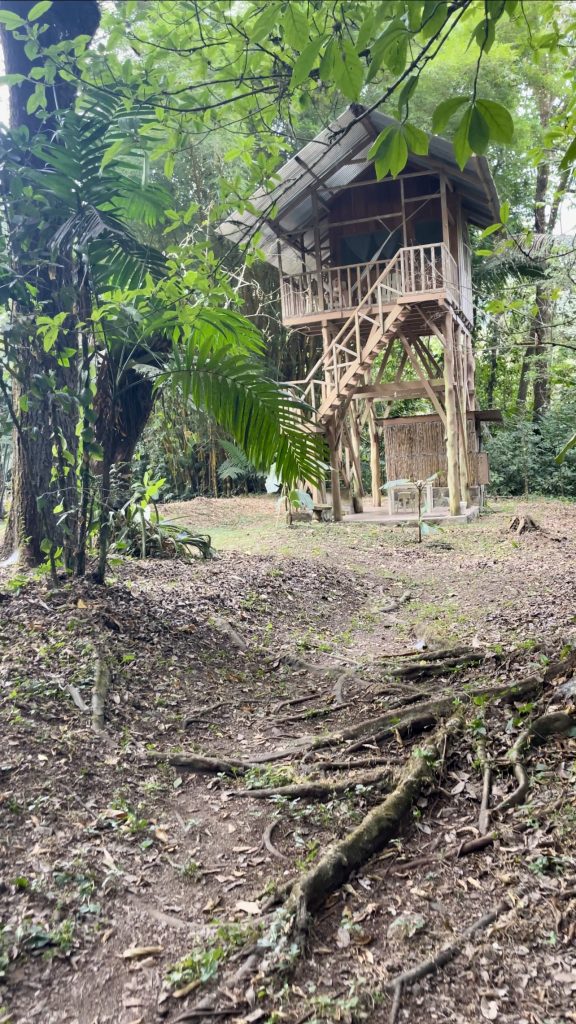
top-left (219, 106), bottom-right (499, 272)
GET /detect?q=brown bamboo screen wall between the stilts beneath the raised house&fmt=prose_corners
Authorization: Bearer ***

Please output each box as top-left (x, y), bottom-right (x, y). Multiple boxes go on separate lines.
top-left (380, 416), bottom-right (488, 486)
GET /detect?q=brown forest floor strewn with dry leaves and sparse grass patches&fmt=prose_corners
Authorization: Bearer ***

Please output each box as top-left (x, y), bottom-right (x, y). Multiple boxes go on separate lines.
top-left (0, 498), bottom-right (576, 1024)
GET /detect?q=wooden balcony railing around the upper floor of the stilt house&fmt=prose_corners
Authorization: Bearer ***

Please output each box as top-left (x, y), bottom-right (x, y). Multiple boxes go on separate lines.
top-left (281, 243), bottom-right (472, 326)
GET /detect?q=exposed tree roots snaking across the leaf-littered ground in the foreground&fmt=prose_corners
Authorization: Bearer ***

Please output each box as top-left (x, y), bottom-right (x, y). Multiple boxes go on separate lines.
top-left (172, 655), bottom-right (574, 1021)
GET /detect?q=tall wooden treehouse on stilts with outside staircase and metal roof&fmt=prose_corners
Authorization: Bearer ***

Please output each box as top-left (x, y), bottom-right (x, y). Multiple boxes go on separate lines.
top-left (221, 106), bottom-right (498, 520)
